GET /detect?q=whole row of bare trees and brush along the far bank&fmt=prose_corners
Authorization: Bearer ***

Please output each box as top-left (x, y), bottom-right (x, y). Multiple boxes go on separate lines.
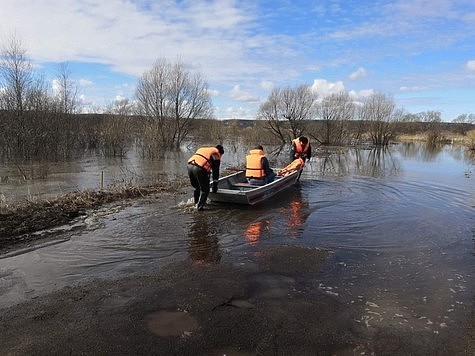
top-left (0, 36), bottom-right (475, 160)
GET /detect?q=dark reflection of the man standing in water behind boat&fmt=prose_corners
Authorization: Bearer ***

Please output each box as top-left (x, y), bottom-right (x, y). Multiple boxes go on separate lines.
top-left (188, 214), bottom-right (221, 264)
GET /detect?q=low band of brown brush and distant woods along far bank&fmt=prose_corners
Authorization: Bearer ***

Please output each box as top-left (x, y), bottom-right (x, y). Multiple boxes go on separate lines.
top-left (0, 110), bottom-right (475, 162)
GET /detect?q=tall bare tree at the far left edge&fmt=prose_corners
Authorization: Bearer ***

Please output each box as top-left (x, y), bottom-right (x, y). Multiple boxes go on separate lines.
top-left (0, 35), bottom-right (34, 113)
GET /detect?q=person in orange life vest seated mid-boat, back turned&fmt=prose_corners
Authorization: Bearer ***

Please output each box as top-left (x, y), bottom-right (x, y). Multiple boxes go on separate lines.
top-left (246, 145), bottom-right (275, 185)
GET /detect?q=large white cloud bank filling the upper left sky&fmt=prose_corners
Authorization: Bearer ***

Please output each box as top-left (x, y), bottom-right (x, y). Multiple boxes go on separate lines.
top-left (0, 0), bottom-right (260, 78)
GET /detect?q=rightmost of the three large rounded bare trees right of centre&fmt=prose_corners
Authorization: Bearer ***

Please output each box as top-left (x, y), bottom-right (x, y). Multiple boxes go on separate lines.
top-left (360, 93), bottom-right (403, 146)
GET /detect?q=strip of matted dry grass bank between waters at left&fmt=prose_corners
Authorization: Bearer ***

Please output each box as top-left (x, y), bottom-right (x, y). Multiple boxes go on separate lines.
top-left (0, 179), bottom-right (188, 252)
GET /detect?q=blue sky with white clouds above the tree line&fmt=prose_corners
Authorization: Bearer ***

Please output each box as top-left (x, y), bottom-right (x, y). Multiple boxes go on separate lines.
top-left (0, 0), bottom-right (475, 121)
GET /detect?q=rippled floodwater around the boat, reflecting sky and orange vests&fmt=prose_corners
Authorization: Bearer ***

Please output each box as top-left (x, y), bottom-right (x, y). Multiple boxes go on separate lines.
top-left (0, 144), bottom-right (475, 344)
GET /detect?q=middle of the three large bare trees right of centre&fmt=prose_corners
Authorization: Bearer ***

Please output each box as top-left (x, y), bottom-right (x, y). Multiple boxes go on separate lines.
top-left (315, 92), bottom-right (355, 145)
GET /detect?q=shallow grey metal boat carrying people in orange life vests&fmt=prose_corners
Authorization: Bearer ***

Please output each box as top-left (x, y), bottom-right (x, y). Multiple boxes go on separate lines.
top-left (209, 170), bottom-right (300, 205)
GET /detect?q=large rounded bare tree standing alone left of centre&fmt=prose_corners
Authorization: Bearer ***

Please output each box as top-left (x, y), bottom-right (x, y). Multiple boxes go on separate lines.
top-left (136, 59), bottom-right (213, 149)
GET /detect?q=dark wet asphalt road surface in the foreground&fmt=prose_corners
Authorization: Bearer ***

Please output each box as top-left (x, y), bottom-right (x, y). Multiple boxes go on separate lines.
top-left (0, 246), bottom-right (474, 355)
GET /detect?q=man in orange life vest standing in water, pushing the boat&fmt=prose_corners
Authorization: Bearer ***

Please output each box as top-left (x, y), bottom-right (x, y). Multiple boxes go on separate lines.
top-left (188, 145), bottom-right (224, 210)
